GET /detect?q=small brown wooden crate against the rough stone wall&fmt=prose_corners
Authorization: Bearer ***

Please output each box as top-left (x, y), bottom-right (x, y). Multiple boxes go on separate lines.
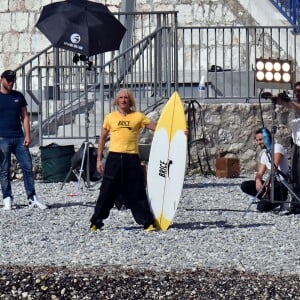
top-left (216, 157), bottom-right (240, 178)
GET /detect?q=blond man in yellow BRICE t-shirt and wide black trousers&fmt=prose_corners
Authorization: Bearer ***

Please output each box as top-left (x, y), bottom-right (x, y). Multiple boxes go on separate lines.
top-left (90, 89), bottom-right (156, 231)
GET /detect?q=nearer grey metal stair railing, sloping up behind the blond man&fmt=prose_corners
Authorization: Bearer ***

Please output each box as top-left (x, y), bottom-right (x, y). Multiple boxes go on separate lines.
top-left (26, 28), bottom-right (176, 144)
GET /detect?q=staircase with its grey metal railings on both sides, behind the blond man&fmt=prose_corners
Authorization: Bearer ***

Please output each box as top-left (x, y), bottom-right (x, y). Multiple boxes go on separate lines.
top-left (16, 12), bottom-right (176, 145)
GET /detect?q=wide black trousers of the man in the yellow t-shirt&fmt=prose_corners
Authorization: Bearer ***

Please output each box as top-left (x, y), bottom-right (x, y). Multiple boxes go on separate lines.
top-left (91, 152), bottom-right (154, 227)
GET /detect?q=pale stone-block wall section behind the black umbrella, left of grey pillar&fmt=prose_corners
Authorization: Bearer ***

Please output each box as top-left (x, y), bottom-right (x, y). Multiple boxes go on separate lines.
top-left (0, 0), bottom-right (121, 70)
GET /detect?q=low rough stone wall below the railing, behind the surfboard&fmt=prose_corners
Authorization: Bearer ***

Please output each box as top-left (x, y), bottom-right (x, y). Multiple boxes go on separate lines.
top-left (12, 103), bottom-right (293, 179)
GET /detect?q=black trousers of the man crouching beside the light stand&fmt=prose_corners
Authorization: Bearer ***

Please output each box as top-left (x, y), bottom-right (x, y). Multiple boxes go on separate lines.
top-left (241, 180), bottom-right (288, 212)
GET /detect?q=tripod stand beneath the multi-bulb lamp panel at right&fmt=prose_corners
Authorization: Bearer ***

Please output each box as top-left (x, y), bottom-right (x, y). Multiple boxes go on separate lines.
top-left (243, 101), bottom-right (300, 217)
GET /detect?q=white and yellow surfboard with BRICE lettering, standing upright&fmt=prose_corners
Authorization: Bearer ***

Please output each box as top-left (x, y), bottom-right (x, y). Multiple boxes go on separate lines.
top-left (147, 92), bottom-right (187, 230)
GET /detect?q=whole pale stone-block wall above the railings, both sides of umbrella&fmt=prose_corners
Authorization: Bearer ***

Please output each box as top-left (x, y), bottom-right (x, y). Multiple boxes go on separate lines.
top-left (0, 0), bottom-right (255, 70)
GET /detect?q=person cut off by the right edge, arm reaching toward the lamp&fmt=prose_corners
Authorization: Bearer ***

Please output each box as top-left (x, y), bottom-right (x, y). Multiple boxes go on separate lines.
top-left (272, 81), bottom-right (300, 214)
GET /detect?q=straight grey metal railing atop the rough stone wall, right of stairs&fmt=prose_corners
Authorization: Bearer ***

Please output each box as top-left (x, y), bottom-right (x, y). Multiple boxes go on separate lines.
top-left (177, 26), bottom-right (298, 103)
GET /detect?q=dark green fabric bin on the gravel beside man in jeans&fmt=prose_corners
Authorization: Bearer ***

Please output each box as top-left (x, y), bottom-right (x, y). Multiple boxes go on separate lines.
top-left (40, 143), bottom-right (76, 182)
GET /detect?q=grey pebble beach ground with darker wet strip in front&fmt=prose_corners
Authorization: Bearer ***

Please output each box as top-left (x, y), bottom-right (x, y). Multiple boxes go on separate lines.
top-left (0, 176), bottom-right (300, 299)
